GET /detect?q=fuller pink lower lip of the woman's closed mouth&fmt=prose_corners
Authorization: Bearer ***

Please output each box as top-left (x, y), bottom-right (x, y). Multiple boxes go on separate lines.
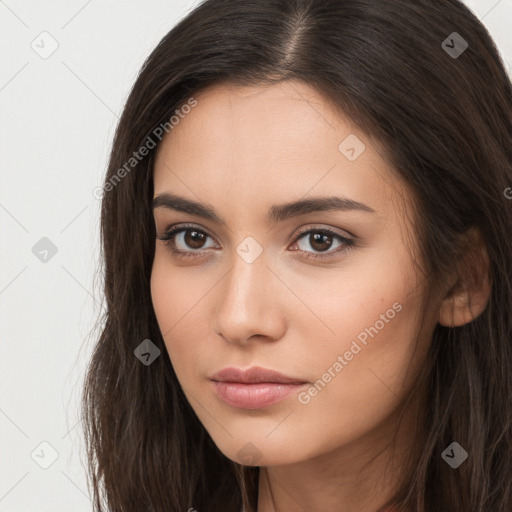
top-left (212, 381), bottom-right (306, 409)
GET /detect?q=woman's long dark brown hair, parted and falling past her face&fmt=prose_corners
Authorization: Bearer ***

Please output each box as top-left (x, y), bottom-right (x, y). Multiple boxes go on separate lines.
top-left (82, 0), bottom-right (512, 512)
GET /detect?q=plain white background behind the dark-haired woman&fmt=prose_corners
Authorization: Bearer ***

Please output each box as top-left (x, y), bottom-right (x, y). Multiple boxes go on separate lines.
top-left (0, 0), bottom-right (512, 512)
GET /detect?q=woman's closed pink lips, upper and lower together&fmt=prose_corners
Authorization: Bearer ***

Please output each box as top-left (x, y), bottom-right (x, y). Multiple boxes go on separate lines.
top-left (210, 366), bottom-right (308, 409)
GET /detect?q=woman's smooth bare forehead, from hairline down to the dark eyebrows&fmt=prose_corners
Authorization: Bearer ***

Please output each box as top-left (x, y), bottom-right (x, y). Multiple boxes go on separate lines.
top-left (154, 81), bottom-right (405, 229)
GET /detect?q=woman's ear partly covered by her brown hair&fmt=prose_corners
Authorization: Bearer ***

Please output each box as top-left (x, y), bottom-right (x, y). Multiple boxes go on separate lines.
top-left (439, 228), bottom-right (491, 327)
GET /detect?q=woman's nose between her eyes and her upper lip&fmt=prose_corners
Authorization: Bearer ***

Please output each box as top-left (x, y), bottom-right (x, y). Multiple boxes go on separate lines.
top-left (214, 252), bottom-right (290, 345)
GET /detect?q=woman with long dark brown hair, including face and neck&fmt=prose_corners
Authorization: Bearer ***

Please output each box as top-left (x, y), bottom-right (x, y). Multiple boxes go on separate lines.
top-left (83, 0), bottom-right (512, 512)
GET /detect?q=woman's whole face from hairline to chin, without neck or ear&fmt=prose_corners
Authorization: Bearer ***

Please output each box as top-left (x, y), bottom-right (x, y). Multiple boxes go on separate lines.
top-left (151, 82), bottom-right (435, 466)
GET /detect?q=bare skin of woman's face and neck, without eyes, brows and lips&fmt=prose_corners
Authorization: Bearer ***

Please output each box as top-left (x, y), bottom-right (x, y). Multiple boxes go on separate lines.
top-left (151, 81), bottom-right (488, 512)
